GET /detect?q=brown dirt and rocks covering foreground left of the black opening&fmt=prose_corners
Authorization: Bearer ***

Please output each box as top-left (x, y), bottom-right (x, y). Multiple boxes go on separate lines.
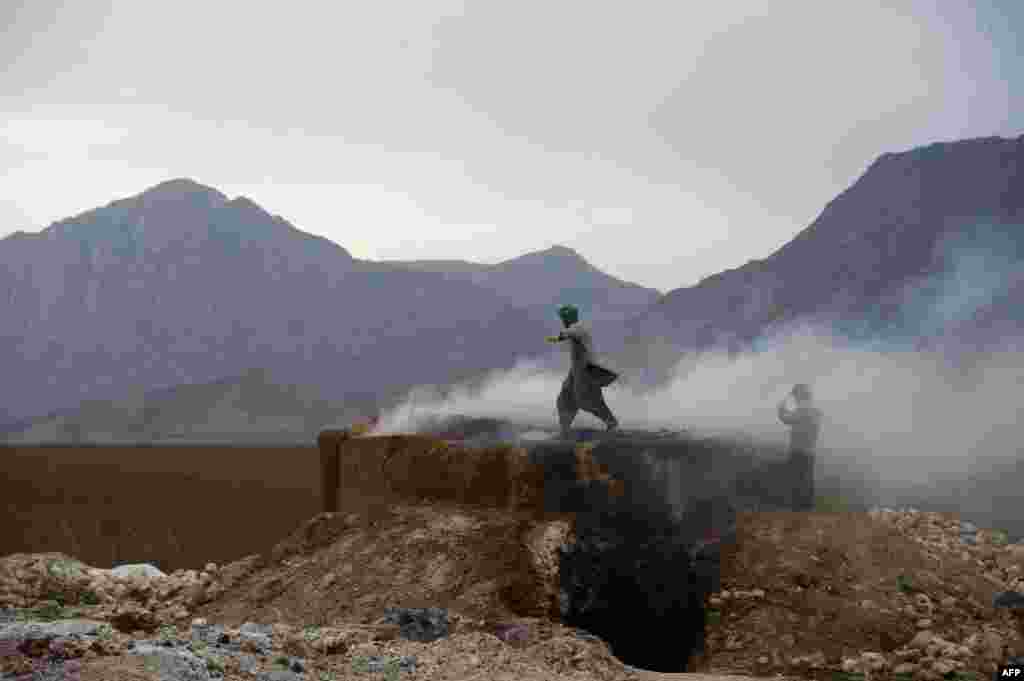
top-left (0, 505), bottom-right (684, 681)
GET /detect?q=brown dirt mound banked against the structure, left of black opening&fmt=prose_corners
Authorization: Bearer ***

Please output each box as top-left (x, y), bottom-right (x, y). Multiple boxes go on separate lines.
top-left (199, 504), bottom-right (571, 626)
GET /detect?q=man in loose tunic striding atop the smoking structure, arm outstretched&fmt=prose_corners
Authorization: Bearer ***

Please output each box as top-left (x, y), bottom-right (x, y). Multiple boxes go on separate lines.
top-left (546, 305), bottom-right (618, 438)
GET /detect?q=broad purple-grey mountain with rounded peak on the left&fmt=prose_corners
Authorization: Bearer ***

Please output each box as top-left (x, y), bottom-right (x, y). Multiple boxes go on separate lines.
top-left (0, 179), bottom-right (593, 427)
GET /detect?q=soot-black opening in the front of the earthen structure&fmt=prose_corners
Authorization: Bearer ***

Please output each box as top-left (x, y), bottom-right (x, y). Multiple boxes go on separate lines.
top-left (531, 442), bottom-right (735, 672)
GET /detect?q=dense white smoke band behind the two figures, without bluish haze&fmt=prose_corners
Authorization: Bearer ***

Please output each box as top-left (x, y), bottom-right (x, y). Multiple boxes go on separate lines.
top-left (377, 313), bottom-right (1024, 483)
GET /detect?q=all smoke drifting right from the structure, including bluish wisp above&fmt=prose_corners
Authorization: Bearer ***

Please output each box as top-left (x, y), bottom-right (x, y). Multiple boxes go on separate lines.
top-left (380, 222), bottom-right (1024, 522)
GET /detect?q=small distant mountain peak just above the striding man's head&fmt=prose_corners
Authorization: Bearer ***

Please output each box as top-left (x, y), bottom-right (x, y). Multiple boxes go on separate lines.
top-left (387, 246), bottom-right (659, 326)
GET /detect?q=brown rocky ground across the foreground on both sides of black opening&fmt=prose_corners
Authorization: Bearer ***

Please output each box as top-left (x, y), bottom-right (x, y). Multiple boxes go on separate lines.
top-left (0, 506), bottom-right (1024, 681)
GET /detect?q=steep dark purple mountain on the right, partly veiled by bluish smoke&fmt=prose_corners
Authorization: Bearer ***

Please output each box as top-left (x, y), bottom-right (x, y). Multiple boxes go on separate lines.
top-left (620, 136), bottom-right (1024, 363)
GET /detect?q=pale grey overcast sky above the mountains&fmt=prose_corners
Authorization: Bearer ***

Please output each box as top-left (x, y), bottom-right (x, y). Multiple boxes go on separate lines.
top-left (0, 0), bottom-right (1024, 290)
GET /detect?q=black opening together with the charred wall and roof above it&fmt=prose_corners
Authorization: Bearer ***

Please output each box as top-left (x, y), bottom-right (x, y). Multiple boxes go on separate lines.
top-left (356, 418), bottom-right (792, 673)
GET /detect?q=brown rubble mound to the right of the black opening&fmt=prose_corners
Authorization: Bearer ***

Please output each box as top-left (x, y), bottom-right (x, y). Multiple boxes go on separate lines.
top-left (708, 511), bottom-right (1024, 681)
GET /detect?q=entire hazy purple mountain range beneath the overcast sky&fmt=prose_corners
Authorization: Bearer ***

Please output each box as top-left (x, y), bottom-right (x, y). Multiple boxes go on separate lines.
top-left (8, 135), bottom-right (1024, 438)
